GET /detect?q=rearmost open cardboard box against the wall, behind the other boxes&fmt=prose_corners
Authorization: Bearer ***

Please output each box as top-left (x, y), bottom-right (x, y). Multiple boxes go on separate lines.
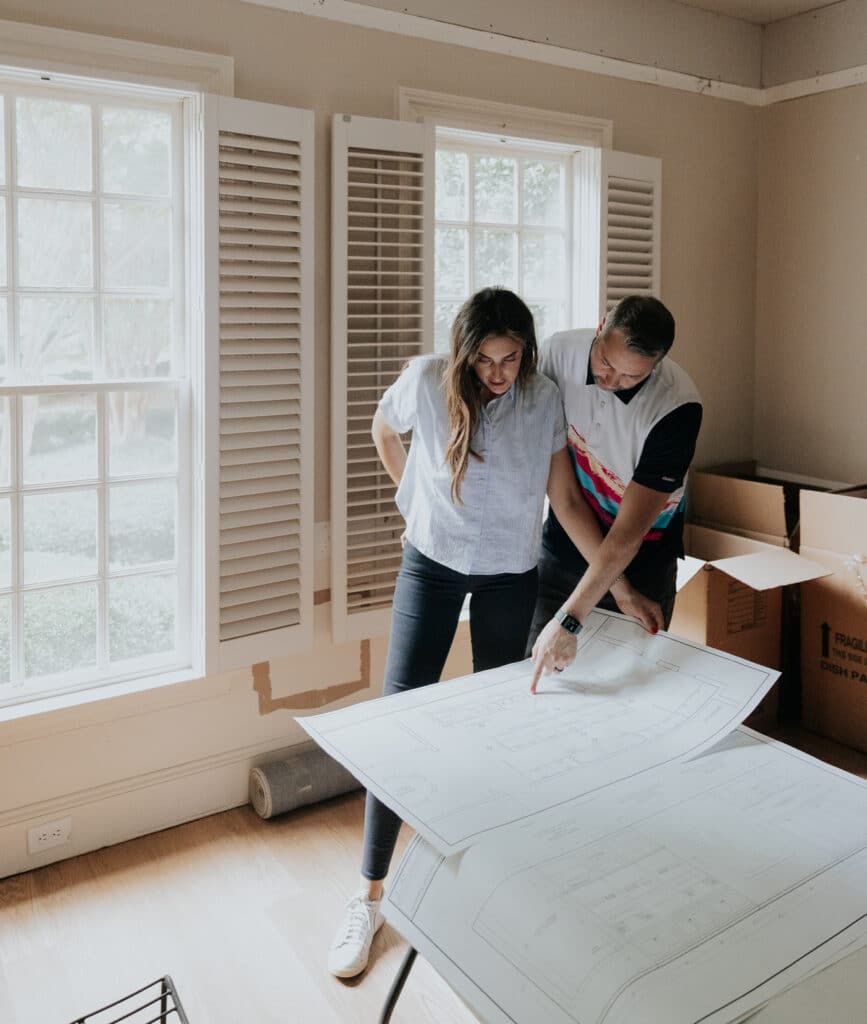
top-left (689, 462), bottom-right (849, 551)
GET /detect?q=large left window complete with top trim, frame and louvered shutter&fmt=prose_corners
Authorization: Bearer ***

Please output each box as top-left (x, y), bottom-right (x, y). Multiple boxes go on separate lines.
top-left (0, 37), bottom-right (314, 708)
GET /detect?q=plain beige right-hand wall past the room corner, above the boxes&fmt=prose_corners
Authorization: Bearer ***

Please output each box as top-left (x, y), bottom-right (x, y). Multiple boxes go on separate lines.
top-left (755, 86), bottom-right (867, 483)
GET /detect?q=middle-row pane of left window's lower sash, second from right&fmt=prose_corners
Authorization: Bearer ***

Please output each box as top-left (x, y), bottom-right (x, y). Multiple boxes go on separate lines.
top-left (24, 490), bottom-right (96, 583)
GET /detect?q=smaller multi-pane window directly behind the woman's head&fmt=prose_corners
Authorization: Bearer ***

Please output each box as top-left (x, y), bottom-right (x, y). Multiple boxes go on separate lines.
top-left (434, 130), bottom-right (575, 351)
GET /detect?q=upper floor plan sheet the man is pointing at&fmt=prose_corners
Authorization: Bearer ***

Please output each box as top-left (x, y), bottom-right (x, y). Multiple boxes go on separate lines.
top-left (298, 611), bottom-right (778, 854)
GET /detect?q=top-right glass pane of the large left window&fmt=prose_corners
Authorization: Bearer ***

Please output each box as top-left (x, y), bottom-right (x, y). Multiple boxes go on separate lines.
top-left (102, 106), bottom-right (172, 196)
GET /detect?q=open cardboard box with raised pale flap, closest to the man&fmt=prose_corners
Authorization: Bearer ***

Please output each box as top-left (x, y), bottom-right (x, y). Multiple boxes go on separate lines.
top-left (669, 524), bottom-right (827, 729)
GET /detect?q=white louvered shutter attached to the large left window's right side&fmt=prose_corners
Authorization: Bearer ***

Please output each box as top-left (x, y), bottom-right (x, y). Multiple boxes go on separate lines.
top-left (205, 96), bottom-right (313, 671)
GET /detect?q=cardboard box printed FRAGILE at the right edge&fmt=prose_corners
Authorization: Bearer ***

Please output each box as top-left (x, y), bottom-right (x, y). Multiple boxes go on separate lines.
top-left (800, 487), bottom-right (867, 751)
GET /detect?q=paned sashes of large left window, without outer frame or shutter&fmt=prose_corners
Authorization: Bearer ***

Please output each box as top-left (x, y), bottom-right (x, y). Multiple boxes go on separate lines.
top-left (0, 78), bottom-right (191, 701)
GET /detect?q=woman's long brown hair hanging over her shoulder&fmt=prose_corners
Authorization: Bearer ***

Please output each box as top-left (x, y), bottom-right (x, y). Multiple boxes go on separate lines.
top-left (442, 288), bottom-right (536, 504)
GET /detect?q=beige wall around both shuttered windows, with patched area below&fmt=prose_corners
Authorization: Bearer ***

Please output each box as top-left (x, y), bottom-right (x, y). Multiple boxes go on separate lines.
top-left (0, 0), bottom-right (760, 876)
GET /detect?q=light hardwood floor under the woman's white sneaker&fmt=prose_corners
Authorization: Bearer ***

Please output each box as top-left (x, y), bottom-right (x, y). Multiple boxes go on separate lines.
top-left (0, 794), bottom-right (476, 1024)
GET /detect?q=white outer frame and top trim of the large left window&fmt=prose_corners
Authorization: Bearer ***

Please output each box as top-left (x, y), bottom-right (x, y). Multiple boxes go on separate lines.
top-left (0, 20), bottom-right (233, 718)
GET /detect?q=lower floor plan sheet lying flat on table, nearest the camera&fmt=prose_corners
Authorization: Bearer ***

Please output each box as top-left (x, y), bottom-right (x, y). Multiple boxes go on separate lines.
top-left (386, 729), bottom-right (867, 1024)
